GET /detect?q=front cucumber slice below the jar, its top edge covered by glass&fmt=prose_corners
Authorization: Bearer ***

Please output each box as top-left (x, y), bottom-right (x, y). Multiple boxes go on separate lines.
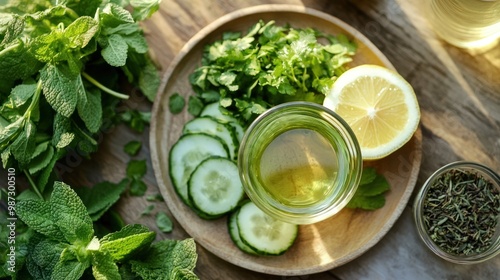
top-left (236, 201), bottom-right (299, 255)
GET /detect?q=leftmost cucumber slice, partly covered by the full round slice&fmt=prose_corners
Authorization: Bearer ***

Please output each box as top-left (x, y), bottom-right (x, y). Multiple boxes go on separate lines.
top-left (169, 133), bottom-right (228, 207)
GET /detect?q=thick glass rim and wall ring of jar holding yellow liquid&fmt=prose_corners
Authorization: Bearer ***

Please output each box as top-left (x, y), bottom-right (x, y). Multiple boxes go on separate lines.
top-left (238, 101), bottom-right (362, 224)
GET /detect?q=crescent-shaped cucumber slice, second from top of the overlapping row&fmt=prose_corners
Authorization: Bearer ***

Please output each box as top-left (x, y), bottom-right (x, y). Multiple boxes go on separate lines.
top-left (182, 116), bottom-right (239, 159)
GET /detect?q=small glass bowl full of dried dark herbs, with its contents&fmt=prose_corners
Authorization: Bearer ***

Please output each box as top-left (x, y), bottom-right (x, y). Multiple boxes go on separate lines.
top-left (413, 161), bottom-right (500, 264)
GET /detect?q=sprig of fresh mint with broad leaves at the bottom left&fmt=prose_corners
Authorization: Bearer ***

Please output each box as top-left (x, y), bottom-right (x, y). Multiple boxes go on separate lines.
top-left (0, 182), bottom-right (198, 280)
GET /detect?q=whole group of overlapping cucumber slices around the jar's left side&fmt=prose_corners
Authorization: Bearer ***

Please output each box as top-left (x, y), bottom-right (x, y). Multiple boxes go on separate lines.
top-left (169, 102), bottom-right (298, 255)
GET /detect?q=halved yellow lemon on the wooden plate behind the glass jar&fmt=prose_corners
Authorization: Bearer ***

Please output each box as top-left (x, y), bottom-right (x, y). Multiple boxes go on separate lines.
top-left (323, 65), bottom-right (420, 160)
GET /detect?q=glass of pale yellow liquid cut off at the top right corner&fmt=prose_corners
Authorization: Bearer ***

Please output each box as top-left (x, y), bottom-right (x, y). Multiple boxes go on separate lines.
top-left (428, 0), bottom-right (500, 50)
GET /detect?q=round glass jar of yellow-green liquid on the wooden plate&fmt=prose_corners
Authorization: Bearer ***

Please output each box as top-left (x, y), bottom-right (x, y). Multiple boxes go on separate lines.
top-left (238, 101), bottom-right (363, 224)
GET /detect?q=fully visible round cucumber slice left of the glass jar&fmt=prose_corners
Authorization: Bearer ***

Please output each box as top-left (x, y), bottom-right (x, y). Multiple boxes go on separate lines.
top-left (188, 157), bottom-right (245, 217)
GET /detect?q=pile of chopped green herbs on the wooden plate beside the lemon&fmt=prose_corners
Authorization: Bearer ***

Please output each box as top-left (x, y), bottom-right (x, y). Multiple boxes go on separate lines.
top-left (190, 21), bottom-right (357, 124)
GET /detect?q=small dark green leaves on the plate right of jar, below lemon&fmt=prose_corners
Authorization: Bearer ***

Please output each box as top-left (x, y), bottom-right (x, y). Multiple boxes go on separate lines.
top-left (346, 167), bottom-right (390, 210)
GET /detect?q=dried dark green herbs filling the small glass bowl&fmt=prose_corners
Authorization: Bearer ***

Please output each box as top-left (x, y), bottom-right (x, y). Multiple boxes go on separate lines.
top-left (423, 169), bottom-right (500, 256)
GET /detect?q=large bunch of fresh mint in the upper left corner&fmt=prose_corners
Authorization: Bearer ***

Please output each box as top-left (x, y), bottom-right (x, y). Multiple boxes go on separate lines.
top-left (0, 0), bottom-right (160, 196)
